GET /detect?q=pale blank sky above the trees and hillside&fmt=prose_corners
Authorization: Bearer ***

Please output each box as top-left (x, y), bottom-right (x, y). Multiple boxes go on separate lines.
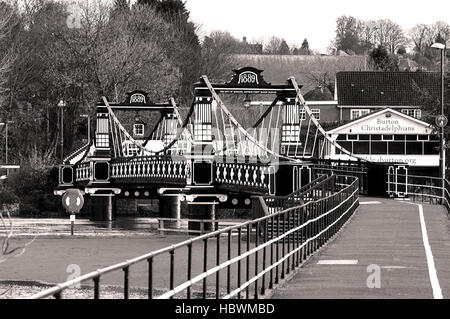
top-left (186, 0), bottom-right (450, 53)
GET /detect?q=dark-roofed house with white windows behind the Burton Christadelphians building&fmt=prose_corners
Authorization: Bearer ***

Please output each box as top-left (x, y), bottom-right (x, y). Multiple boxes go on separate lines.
top-left (335, 72), bottom-right (440, 121)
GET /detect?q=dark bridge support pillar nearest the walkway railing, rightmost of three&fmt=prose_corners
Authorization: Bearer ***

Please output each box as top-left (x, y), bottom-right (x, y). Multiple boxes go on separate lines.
top-left (188, 202), bottom-right (218, 235)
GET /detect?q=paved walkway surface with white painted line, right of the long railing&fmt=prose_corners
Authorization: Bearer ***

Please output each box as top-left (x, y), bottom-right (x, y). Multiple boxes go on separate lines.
top-left (273, 198), bottom-right (450, 299)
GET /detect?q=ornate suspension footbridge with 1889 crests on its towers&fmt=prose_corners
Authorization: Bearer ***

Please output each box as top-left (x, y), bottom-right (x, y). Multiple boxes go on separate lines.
top-left (55, 67), bottom-right (394, 225)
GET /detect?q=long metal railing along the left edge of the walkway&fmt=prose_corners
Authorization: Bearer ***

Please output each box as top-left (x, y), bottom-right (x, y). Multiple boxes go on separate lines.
top-left (32, 176), bottom-right (359, 299)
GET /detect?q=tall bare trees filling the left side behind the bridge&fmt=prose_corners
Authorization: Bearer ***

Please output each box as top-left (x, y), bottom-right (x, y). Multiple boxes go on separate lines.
top-left (0, 0), bottom-right (230, 214)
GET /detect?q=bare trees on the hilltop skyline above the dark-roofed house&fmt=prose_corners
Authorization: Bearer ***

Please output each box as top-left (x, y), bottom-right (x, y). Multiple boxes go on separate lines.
top-left (328, 15), bottom-right (450, 71)
